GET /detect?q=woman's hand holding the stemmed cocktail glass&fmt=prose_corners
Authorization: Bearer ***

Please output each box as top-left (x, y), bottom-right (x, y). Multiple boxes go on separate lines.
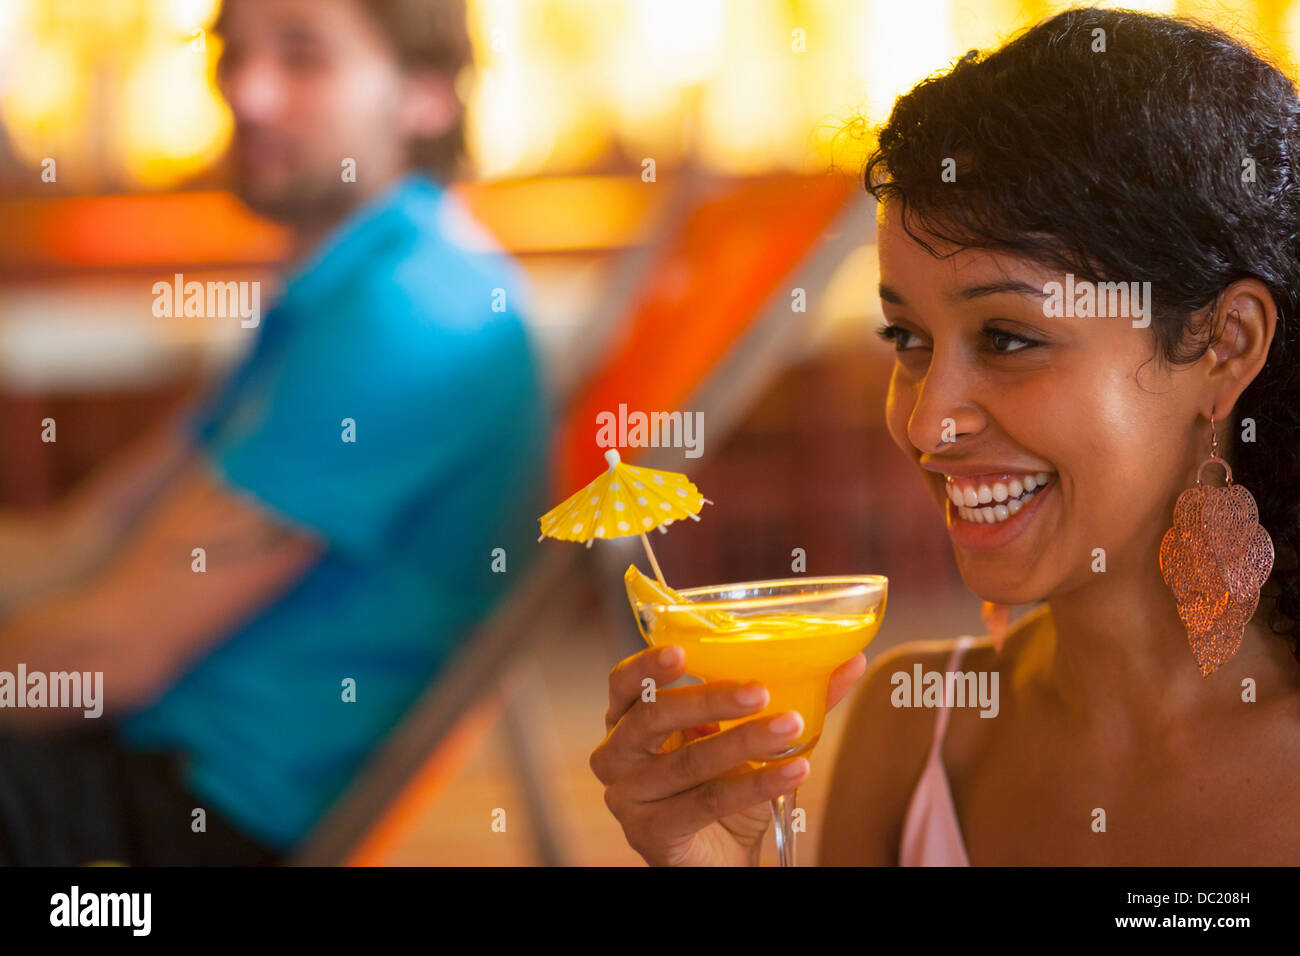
top-left (592, 646), bottom-right (866, 866)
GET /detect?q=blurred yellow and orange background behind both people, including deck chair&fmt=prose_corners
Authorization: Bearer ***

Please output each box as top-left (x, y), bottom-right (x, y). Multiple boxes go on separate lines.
top-left (0, 0), bottom-right (1300, 865)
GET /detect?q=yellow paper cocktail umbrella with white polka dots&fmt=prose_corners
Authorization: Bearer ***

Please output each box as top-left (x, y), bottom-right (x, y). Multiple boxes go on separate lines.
top-left (537, 449), bottom-right (712, 587)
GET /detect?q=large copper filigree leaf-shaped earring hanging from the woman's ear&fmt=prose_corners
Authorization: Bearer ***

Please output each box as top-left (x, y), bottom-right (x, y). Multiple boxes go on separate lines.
top-left (1160, 412), bottom-right (1273, 678)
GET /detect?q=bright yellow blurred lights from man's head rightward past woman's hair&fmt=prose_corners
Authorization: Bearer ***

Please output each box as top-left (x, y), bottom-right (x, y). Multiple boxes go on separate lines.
top-left (469, 0), bottom-right (1300, 178)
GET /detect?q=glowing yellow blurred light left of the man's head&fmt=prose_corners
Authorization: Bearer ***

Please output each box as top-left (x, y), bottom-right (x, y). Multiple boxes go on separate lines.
top-left (0, 0), bottom-right (230, 191)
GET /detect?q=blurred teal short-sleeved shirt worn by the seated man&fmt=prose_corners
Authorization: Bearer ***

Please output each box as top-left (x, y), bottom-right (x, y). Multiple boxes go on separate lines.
top-left (118, 177), bottom-right (550, 849)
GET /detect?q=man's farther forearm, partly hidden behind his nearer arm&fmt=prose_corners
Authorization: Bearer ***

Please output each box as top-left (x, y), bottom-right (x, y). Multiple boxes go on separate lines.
top-left (0, 419), bottom-right (192, 614)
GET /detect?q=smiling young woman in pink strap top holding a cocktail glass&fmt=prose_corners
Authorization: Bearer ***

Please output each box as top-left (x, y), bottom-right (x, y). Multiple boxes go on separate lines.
top-left (592, 3), bottom-right (1300, 865)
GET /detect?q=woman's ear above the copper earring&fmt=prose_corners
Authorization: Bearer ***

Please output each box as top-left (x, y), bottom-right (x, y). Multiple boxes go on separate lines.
top-left (1206, 278), bottom-right (1278, 421)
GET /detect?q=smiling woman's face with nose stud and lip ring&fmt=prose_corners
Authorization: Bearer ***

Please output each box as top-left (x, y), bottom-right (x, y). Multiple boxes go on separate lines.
top-left (878, 202), bottom-right (1201, 604)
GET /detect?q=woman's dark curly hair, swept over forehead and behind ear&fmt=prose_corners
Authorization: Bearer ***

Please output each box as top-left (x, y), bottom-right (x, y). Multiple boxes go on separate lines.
top-left (863, 8), bottom-right (1300, 659)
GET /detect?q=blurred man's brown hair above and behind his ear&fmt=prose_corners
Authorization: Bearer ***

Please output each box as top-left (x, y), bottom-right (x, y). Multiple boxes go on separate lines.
top-left (213, 0), bottom-right (473, 183)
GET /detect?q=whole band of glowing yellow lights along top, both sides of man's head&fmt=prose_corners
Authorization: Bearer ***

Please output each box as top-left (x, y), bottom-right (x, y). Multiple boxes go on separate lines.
top-left (0, 0), bottom-right (1300, 191)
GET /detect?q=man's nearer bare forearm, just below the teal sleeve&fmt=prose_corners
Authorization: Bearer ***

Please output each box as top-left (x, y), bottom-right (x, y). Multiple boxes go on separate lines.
top-left (0, 464), bottom-right (324, 726)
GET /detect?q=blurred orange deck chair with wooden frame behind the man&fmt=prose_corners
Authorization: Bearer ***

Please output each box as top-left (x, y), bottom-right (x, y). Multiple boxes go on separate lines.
top-left (293, 176), bottom-right (874, 865)
